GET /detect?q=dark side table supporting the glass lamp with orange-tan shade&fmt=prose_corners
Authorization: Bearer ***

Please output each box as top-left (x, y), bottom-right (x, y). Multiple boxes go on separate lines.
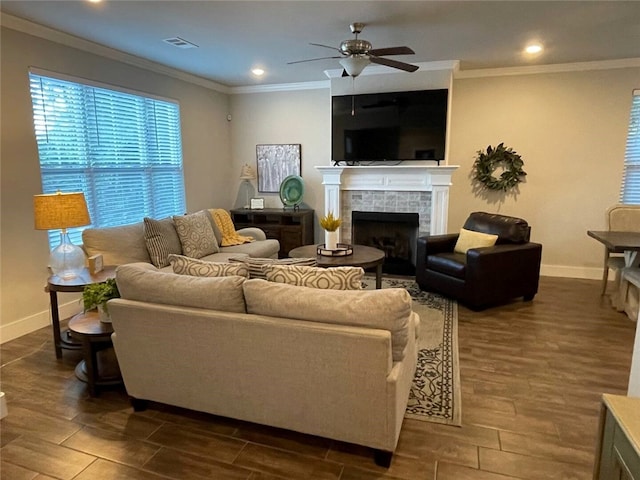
top-left (44, 266), bottom-right (116, 358)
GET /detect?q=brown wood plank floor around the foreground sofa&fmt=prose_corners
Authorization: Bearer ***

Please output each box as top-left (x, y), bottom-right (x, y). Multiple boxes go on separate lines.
top-left (0, 277), bottom-right (635, 480)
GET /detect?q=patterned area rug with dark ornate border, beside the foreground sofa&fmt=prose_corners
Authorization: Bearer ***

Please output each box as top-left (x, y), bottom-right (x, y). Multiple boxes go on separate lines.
top-left (363, 275), bottom-right (462, 426)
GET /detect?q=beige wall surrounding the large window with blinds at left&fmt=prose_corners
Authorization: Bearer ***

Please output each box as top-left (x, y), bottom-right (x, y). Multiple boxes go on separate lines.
top-left (0, 28), bottom-right (232, 341)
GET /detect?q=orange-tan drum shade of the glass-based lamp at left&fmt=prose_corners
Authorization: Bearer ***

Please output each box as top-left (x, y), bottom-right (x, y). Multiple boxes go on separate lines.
top-left (33, 192), bottom-right (91, 230)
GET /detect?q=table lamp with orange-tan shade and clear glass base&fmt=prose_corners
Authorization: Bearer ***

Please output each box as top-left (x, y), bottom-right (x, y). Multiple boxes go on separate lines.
top-left (33, 191), bottom-right (91, 279)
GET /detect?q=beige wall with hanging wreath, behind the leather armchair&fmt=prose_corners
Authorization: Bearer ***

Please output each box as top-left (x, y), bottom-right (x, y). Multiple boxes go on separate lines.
top-left (449, 68), bottom-right (640, 278)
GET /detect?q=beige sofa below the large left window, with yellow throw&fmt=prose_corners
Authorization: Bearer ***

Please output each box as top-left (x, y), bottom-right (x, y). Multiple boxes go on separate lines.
top-left (82, 210), bottom-right (280, 271)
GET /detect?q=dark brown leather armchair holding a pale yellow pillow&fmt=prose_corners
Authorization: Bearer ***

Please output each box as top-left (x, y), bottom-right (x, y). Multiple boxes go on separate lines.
top-left (416, 212), bottom-right (542, 310)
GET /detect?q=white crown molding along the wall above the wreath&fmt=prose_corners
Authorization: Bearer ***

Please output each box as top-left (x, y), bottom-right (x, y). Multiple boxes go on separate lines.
top-left (454, 58), bottom-right (640, 79)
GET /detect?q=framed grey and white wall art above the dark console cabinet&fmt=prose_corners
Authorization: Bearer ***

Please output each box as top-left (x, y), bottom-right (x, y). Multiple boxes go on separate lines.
top-left (256, 143), bottom-right (301, 193)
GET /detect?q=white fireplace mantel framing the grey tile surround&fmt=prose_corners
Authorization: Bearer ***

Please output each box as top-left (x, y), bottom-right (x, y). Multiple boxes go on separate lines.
top-left (315, 164), bottom-right (459, 235)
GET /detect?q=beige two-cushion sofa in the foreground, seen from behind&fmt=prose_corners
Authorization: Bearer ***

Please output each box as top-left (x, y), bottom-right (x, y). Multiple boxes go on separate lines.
top-left (109, 263), bottom-right (419, 466)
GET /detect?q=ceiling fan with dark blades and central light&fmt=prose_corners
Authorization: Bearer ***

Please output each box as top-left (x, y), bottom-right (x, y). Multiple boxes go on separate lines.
top-left (288, 22), bottom-right (418, 78)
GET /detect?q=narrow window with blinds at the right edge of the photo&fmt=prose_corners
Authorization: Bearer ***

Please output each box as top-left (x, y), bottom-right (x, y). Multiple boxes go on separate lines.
top-left (620, 90), bottom-right (640, 204)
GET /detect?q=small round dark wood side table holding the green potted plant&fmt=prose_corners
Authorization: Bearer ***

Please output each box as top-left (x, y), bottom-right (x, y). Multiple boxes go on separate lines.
top-left (69, 311), bottom-right (122, 397)
